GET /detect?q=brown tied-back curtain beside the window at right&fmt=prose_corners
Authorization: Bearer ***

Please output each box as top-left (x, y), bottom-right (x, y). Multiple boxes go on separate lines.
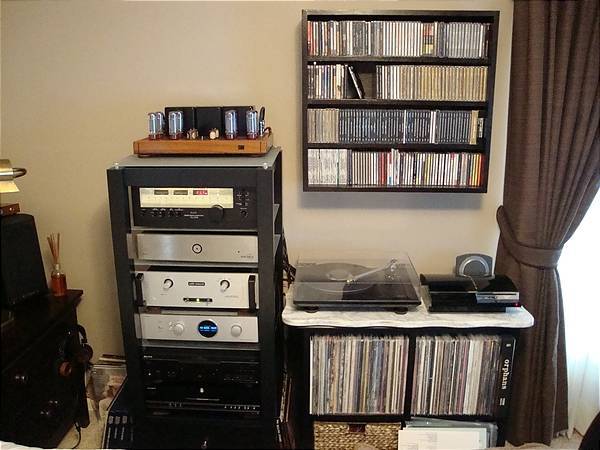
top-left (496, 0), bottom-right (600, 445)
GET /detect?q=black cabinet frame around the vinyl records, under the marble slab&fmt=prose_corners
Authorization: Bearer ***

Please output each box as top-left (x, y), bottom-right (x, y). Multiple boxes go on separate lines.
top-left (287, 326), bottom-right (519, 448)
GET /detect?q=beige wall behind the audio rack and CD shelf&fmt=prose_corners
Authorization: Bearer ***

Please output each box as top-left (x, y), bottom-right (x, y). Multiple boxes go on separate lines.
top-left (1, 0), bottom-right (512, 355)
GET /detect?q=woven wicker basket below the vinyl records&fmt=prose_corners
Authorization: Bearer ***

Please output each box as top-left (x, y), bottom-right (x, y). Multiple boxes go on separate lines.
top-left (314, 421), bottom-right (400, 450)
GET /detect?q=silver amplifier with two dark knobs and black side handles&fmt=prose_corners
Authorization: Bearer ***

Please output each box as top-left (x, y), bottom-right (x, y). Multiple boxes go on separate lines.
top-left (135, 270), bottom-right (258, 310)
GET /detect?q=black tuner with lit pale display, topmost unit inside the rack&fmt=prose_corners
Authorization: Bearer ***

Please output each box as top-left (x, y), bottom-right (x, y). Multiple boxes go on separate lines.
top-left (131, 187), bottom-right (256, 230)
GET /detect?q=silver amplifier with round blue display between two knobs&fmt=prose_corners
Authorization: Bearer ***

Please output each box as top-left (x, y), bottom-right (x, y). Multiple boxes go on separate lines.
top-left (140, 313), bottom-right (258, 342)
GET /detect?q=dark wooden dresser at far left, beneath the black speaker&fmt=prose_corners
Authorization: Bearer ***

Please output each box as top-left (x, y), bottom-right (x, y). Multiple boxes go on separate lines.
top-left (0, 290), bottom-right (89, 448)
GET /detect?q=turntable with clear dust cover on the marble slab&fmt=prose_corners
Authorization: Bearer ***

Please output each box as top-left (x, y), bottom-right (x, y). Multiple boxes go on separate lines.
top-left (294, 256), bottom-right (420, 312)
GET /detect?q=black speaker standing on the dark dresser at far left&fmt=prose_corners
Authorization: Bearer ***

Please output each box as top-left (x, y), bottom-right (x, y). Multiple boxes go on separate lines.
top-left (0, 214), bottom-right (48, 306)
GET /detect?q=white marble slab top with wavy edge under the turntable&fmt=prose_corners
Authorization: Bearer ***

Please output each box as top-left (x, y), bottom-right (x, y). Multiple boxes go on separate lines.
top-left (282, 289), bottom-right (534, 328)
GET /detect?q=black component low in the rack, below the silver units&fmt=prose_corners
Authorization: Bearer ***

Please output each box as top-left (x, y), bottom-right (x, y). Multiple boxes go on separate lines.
top-left (142, 347), bottom-right (260, 415)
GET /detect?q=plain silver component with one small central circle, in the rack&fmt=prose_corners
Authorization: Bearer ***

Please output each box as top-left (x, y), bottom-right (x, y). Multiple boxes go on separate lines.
top-left (129, 233), bottom-right (258, 263)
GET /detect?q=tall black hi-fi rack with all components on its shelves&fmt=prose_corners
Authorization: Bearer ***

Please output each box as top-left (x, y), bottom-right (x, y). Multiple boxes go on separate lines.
top-left (107, 148), bottom-right (284, 448)
